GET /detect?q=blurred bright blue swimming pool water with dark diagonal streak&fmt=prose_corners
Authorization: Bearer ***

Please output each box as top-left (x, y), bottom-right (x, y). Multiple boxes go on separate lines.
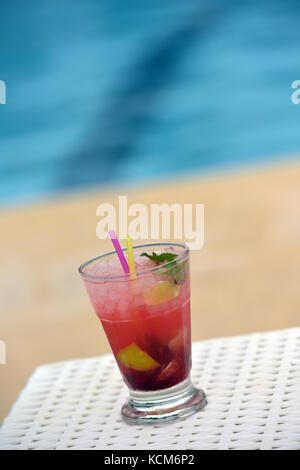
top-left (0, 0), bottom-right (300, 206)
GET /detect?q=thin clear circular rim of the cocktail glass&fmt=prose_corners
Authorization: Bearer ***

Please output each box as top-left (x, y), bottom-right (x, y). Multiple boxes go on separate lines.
top-left (78, 242), bottom-right (190, 281)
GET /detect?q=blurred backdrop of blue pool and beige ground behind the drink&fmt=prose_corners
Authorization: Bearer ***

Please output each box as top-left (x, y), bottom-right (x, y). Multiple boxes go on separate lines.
top-left (0, 0), bottom-right (300, 421)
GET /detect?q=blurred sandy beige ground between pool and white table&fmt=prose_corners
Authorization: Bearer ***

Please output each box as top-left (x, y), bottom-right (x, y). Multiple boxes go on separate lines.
top-left (0, 164), bottom-right (300, 421)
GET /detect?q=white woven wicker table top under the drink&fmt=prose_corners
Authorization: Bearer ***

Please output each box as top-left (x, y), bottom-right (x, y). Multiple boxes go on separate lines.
top-left (0, 328), bottom-right (300, 450)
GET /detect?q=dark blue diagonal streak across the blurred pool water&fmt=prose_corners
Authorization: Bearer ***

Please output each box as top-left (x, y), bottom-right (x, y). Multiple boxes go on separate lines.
top-left (61, 2), bottom-right (230, 189)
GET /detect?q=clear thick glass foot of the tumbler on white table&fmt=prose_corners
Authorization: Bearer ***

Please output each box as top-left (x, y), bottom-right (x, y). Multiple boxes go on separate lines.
top-left (122, 377), bottom-right (207, 424)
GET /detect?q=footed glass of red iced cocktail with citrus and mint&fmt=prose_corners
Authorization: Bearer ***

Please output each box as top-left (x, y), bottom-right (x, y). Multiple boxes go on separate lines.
top-left (79, 243), bottom-right (206, 424)
